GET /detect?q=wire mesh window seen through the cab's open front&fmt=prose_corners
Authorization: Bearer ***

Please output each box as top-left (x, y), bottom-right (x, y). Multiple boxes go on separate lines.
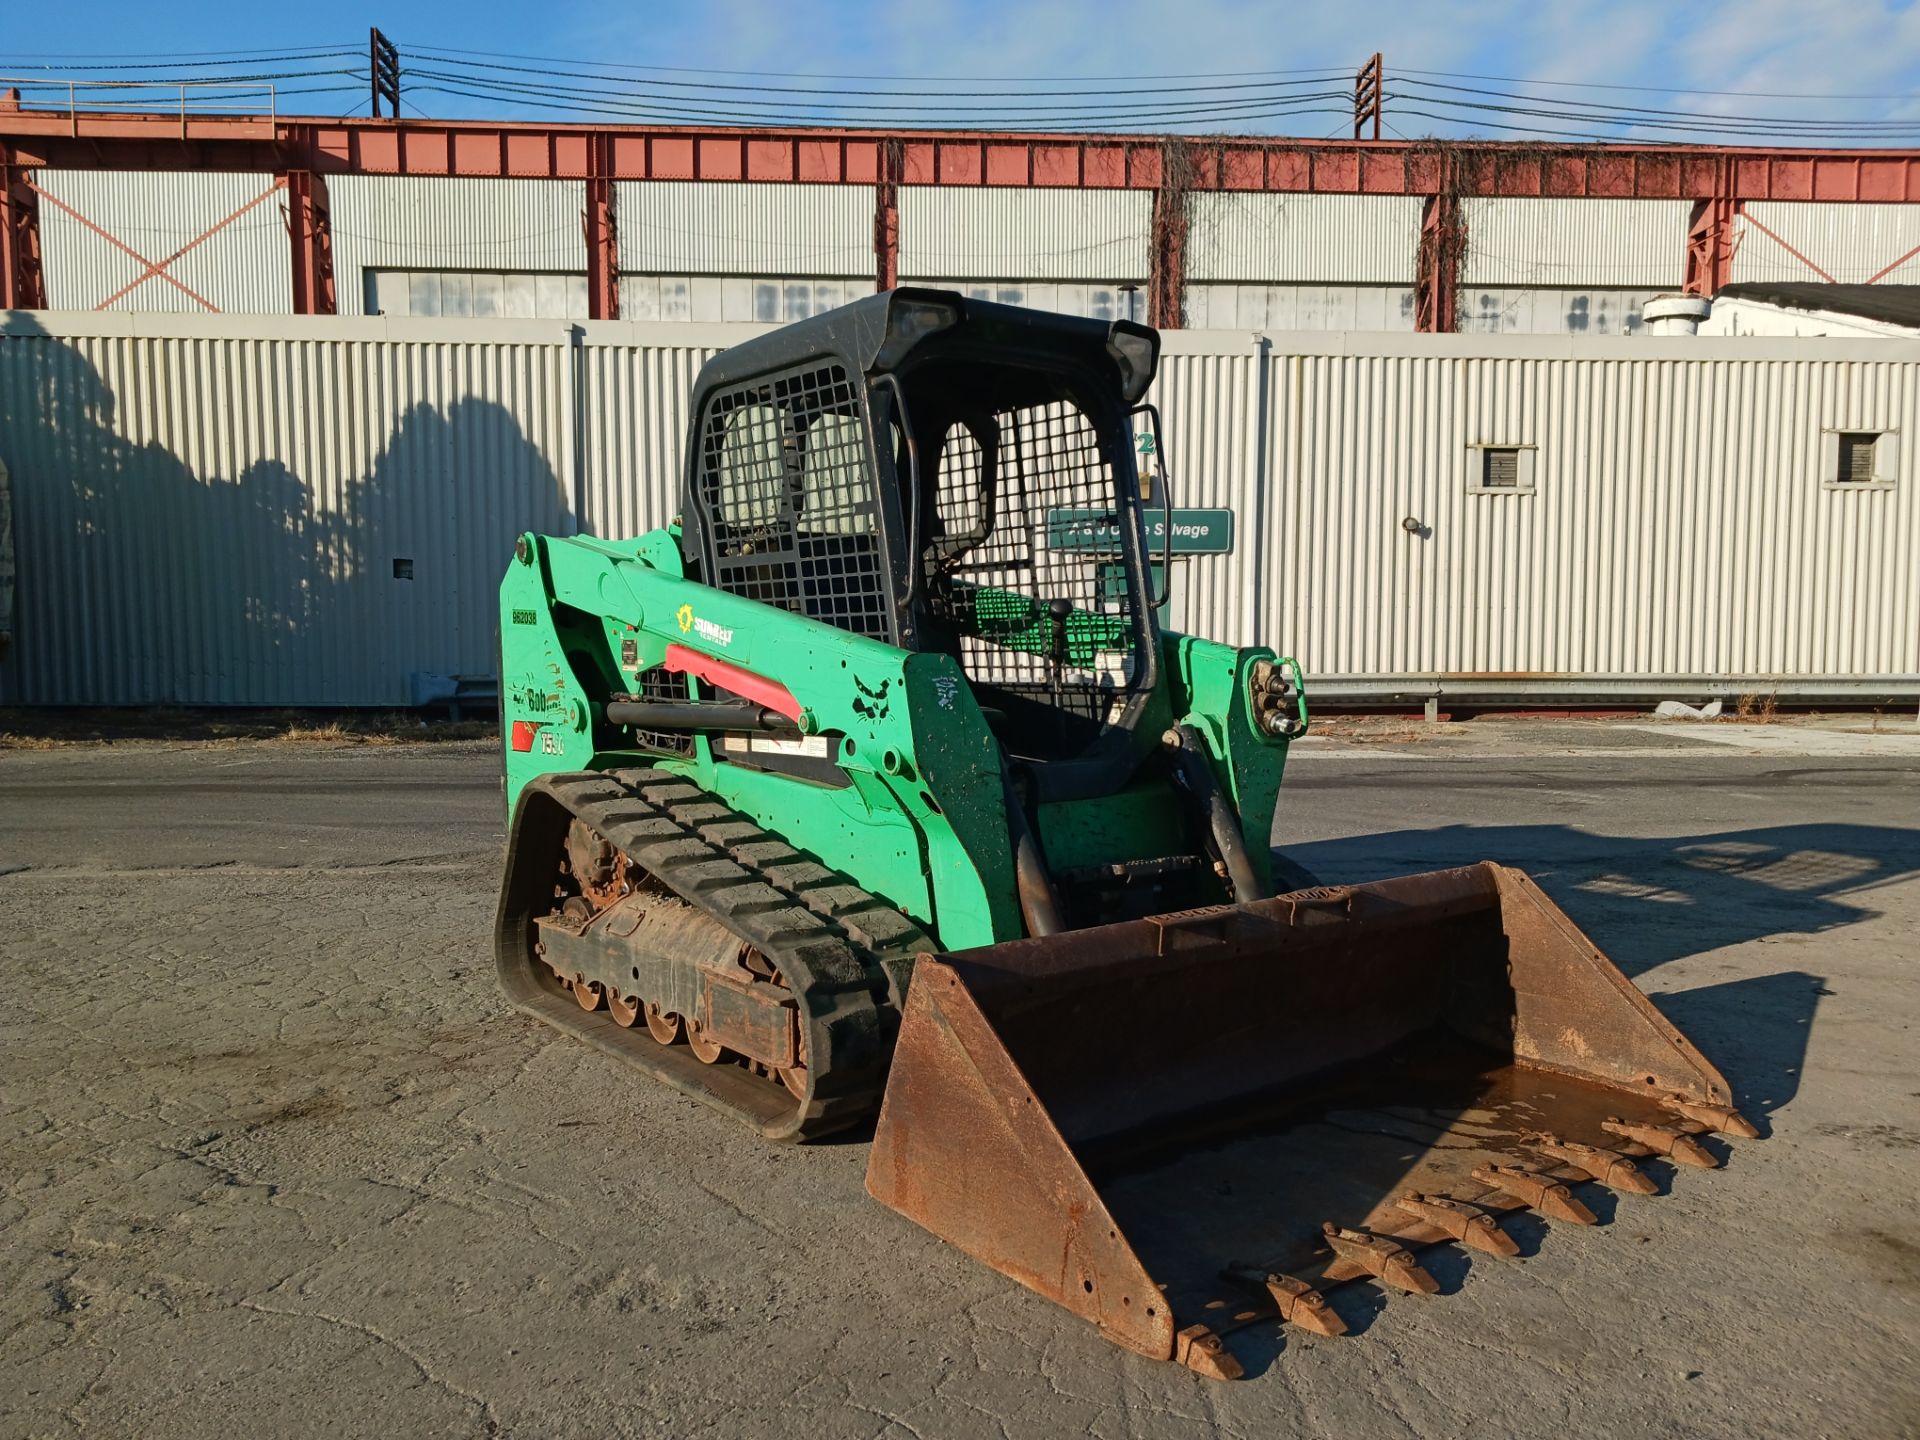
top-left (925, 399), bottom-right (1140, 724)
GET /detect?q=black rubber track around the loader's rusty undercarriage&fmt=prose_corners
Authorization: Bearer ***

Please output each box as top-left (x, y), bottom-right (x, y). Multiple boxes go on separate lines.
top-left (499, 768), bottom-right (935, 1140)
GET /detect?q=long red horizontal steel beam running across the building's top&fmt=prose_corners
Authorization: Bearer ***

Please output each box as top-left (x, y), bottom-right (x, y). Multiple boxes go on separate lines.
top-left (0, 109), bottom-right (1920, 202)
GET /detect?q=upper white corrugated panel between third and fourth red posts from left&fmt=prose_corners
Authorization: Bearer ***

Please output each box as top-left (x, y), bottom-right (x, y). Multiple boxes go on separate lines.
top-left (614, 180), bottom-right (874, 280)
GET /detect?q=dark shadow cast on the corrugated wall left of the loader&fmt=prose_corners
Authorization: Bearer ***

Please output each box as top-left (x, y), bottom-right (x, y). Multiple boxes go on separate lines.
top-left (0, 311), bottom-right (566, 705)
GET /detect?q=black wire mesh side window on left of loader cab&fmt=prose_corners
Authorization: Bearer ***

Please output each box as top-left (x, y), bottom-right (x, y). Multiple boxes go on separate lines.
top-left (701, 365), bottom-right (897, 641)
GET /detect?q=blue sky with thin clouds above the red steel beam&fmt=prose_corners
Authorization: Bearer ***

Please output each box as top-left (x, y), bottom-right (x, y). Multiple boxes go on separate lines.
top-left (0, 0), bottom-right (1920, 144)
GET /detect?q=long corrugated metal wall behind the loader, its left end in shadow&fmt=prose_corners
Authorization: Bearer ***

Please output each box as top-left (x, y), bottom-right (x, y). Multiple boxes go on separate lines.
top-left (0, 313), bottom-right (1920, 705)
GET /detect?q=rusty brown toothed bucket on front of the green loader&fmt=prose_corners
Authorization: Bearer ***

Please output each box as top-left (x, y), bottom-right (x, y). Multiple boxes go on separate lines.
top-left (866, 864), bottom-right (1753, 1377)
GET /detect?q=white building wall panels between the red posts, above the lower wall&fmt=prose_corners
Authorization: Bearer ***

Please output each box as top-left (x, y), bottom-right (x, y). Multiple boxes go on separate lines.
top-left (36, 169), bottom-right (1920, 336)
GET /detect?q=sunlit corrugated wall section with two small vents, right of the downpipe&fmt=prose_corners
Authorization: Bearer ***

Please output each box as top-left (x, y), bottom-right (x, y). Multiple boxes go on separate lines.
top-left (1263, 340), bottom-right (1920, 687)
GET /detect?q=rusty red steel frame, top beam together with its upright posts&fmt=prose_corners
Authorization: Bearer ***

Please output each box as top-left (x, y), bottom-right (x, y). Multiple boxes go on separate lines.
top-left (0, 104), bottom-right (1920, 328)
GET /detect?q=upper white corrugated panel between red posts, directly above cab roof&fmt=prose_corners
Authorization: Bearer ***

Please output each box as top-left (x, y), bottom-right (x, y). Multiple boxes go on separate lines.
top-left (900, 184), bottom-right (1154, 282)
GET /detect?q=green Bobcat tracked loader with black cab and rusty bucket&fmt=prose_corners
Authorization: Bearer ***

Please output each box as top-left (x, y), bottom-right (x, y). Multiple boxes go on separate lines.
top-left (495, 290), bottom-right (1753, 1377)
